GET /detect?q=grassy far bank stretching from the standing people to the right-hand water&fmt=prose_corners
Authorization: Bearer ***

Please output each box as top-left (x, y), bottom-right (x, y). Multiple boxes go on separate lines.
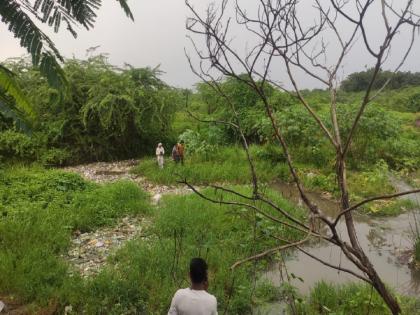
top-left (132, 146), bottom-right (415, 216)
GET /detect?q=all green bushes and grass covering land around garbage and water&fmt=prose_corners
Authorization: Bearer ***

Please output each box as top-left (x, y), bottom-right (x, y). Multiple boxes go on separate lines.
top-left (0, 56), bottom-right (420, 314)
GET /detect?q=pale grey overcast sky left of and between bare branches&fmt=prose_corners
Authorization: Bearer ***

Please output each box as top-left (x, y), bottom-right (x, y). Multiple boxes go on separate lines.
top-left (0, 0), bottom-right (420, 88)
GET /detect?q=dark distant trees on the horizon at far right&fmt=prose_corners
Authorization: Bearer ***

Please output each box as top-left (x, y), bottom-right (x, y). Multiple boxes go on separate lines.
top-left (341, 68), bottom-right (420, 92)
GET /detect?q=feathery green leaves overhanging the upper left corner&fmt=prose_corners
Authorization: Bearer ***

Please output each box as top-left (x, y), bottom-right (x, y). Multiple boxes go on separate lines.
top-left (0, 0), bottom-right (133, 127)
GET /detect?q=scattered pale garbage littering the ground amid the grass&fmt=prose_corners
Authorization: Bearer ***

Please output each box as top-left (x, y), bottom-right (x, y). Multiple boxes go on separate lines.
top-left (64, 160), bottom-right (196, 277)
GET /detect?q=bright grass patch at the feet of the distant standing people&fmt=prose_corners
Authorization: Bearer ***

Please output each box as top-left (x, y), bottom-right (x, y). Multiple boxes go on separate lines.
top-left (133, 147), bottom-right (289, 185)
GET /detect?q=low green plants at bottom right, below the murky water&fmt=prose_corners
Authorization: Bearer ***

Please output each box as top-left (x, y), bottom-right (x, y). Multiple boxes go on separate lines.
top-left (298, 282), bottom-right (420, 315)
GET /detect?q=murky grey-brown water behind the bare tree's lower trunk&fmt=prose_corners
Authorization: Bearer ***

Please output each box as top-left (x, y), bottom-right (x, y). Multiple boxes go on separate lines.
top-left (264, 180), bottom-right (420, 302)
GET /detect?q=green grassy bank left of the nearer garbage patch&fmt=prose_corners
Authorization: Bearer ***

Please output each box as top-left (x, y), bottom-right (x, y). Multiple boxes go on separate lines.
top-left (0, 168), bottom-right (150, 306)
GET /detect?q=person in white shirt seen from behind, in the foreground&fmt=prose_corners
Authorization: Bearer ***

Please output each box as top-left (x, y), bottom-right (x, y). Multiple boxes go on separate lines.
top-left (168, 258), bottom-right (217, 315)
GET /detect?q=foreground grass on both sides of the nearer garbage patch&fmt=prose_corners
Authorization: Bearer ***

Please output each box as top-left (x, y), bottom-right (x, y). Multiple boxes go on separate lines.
top-left (0, 167), bottom-right (303, 314)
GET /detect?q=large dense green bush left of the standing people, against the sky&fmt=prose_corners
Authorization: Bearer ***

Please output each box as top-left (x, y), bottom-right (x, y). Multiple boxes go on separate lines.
top-left (0, 56), bottom-right (181, 164)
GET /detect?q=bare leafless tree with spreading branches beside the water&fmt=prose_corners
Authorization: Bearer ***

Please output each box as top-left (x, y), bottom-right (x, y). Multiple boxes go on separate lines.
top-left (184, 0), bottom-right (420, 314)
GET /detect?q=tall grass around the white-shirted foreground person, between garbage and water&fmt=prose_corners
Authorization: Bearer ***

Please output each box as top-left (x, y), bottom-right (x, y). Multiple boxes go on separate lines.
top-left (67, 190), bottom-right (302, 314)
